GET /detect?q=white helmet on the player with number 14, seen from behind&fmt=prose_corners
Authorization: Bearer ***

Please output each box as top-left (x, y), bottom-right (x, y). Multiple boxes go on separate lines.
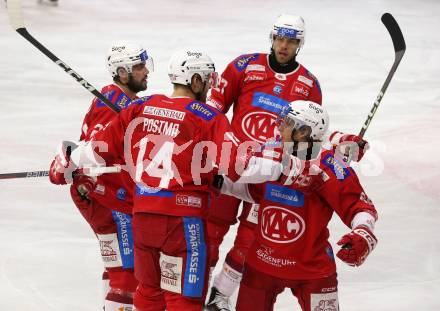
top-left (168, 49), bottom-right (217, 86)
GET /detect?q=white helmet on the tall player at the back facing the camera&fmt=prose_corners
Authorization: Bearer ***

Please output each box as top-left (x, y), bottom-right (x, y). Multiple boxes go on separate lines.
top-left (270, 14), bottom-right (306, 49)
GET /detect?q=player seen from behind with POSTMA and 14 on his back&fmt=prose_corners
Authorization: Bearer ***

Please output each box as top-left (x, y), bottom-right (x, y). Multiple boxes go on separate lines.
top-left (51, 50), bottom-right (281, 311)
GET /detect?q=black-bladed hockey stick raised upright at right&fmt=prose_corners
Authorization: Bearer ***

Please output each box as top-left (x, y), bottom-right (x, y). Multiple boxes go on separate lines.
top-left (359, 13), bottom-right (406, 137)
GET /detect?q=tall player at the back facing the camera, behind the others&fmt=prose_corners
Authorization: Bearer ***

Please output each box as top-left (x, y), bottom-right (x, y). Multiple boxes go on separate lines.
top-left (207, 14), bottom-right (370, 311)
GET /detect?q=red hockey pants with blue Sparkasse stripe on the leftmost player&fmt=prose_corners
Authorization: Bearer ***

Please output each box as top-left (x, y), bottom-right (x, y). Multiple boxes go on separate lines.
top-left (70, 185), bottom-right (138, 305)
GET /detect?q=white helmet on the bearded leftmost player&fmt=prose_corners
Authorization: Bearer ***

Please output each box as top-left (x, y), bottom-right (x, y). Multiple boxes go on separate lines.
top-left (107, 42), bottom-right (154, 78)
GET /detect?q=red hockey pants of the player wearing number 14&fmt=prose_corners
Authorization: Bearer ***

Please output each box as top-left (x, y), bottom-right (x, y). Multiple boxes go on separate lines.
top-left (133, 213), bottom-right (209, 311)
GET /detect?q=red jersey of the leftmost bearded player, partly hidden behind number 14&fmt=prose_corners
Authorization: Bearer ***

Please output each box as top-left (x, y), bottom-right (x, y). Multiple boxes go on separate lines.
top-left (80, 84), bottom-right (132, 214)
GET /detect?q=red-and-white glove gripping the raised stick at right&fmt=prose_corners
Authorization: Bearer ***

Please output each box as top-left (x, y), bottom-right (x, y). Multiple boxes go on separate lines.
top-left (330, 132), bottom-right (370, 162)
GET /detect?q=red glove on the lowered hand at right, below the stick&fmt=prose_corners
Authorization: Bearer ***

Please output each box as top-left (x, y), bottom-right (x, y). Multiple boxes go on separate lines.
top-left (336, 226), bottom-right (377, 267)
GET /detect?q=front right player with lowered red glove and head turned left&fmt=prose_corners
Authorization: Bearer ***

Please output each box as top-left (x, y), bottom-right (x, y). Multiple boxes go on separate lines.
top-left (222, 101), bottom-right (377, 311)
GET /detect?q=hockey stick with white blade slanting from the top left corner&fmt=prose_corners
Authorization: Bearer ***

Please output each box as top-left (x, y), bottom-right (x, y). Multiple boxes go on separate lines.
top-left (7, 0), bottom-right (120, 113)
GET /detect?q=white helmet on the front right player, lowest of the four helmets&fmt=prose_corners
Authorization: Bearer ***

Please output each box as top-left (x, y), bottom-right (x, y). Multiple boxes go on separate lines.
top-left (279, 100), bottom-right (330, 141)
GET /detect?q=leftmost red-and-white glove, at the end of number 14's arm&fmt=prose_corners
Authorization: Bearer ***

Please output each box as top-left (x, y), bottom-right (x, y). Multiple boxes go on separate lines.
top-left (49, 141), bottom-right (77, 185)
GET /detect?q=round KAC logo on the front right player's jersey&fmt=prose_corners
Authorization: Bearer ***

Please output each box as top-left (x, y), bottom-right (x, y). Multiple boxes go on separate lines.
top-left (261, 206), bottom-right (306, 243)
